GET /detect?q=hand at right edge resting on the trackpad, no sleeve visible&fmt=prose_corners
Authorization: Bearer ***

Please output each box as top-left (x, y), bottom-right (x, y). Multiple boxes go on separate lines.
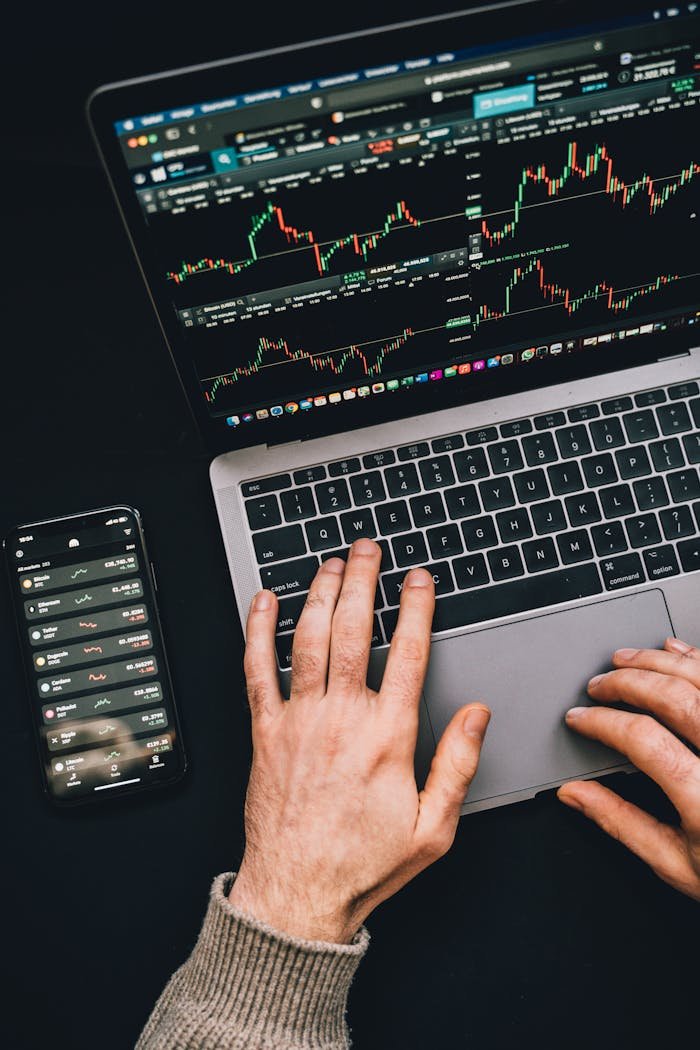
top-left (558, 638), bottom-right (700, 901)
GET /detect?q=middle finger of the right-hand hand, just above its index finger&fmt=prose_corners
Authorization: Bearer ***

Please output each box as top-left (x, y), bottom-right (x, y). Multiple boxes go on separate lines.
top-left (588, 663), bottom-right (700, 744)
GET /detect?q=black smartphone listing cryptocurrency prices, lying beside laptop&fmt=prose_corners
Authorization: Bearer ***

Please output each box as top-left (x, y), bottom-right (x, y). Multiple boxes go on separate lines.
top-left (3, 506), bottom-right (186, 805)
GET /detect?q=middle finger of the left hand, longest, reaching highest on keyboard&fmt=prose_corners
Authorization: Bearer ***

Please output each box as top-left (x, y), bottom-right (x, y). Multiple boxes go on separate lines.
top-left (328, 540), bottom-right (382, 694)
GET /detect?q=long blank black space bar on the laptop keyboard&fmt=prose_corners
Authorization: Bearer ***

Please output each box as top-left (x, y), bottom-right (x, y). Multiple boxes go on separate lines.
top-left (432, 559), bottom-right (604, 631)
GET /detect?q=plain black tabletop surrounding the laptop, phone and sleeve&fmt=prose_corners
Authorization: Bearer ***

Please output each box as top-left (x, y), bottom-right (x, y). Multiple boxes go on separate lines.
top-left (0, 0), bottom-right (700, 1050)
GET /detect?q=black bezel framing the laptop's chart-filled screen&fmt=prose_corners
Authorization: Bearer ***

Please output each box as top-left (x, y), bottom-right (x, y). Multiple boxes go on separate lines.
top-left (87, 0), bottom-right (693, 454)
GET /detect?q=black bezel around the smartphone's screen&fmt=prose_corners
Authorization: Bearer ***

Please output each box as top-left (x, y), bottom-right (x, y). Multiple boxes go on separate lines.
top-left (2, 504), bottom-right (188, 807)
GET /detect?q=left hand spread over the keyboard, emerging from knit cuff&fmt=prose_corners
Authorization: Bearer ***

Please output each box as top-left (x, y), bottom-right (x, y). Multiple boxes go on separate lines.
top-left (229, 540), bottom-right (489, 943)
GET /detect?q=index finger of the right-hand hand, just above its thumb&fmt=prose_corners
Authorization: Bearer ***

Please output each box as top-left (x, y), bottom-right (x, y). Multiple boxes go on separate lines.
top-left (567, 708), bottom-right (700, 823)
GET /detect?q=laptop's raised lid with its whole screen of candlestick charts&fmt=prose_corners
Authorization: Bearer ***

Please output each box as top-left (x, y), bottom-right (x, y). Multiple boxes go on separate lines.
top-left (88, 0), bottom-right (700, 452)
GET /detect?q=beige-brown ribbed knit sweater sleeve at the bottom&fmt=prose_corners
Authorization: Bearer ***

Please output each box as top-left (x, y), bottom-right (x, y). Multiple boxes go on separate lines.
top-left (136, 874), bottom-right (369, 1050)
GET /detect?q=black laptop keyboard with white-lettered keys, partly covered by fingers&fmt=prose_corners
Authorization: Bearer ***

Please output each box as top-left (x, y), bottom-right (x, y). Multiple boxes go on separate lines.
top-left (241, 382), bottom-right (700, 668)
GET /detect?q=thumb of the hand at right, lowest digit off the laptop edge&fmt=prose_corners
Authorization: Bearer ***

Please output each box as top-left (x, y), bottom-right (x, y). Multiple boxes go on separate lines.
top-left (557, 780), bottom-right (693, 889)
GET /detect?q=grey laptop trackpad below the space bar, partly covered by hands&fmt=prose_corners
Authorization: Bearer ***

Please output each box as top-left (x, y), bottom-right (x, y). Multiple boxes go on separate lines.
top-left (425, 590), bottom-right (673, 804)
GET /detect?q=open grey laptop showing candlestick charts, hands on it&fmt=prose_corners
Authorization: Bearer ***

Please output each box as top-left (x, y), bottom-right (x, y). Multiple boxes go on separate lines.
top-left (88, 2), bottom-right (700, 813)
